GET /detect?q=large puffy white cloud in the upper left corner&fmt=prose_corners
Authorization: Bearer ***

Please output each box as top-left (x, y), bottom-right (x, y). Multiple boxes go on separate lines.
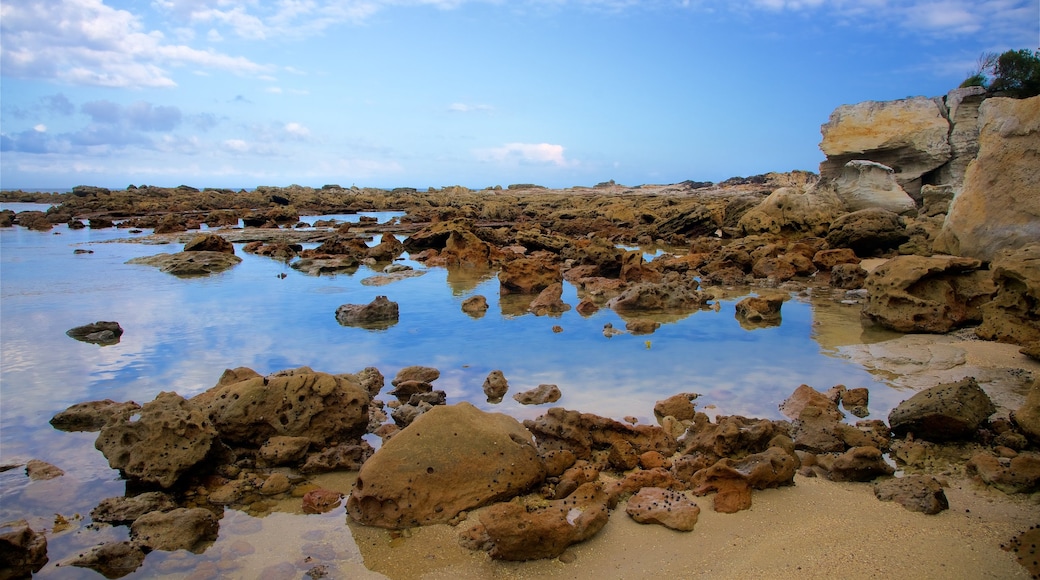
top-left (0, 0), bottom-right (264, 87)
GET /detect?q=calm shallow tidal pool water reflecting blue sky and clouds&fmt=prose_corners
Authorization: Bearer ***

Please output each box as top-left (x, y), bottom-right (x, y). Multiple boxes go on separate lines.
top-left (0, 204), bottom-right (903, 577)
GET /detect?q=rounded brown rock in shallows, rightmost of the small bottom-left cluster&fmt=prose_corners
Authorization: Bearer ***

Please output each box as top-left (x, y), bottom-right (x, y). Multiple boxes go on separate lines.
top-left (130, 507), bottom-right (219, 554)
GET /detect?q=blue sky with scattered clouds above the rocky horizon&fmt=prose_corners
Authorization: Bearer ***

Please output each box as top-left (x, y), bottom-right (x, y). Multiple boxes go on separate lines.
top-left (0, 0), bottom-right (1040, 189)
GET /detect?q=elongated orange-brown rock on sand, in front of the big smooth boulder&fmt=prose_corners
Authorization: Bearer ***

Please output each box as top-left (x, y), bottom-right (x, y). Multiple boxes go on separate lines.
top-left (463, 483), bottom-right (609, 560)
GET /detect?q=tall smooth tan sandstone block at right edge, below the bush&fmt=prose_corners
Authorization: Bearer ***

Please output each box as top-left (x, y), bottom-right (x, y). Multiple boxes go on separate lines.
top-left (936, 96), bottom-right (1040, 261)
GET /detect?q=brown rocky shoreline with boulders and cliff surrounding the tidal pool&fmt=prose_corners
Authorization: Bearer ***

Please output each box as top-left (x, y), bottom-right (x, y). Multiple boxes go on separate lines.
top-left (0, 87), bottom-right (1040, 578)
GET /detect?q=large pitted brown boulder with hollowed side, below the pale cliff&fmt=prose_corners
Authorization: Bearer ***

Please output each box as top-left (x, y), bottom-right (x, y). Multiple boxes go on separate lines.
top-left (863, 256), bottom-right (993, 333)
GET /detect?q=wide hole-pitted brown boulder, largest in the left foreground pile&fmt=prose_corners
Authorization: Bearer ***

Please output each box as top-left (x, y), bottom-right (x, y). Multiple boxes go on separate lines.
top-left (191, 367), bottom-right (369, 449)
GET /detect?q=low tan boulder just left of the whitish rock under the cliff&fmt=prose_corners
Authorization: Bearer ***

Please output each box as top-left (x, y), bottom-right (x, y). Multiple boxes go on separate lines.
top-left (737, 185), bottom-right (846, 236)
